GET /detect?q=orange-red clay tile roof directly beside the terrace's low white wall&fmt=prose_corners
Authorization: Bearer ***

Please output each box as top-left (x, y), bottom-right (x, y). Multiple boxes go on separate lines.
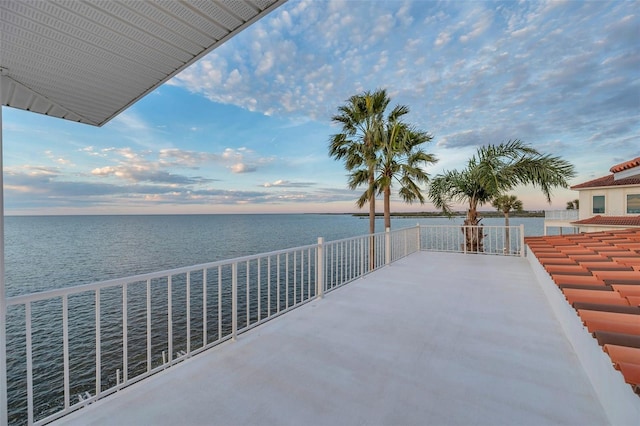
top-left (525, 230), bottom-right (640, 395)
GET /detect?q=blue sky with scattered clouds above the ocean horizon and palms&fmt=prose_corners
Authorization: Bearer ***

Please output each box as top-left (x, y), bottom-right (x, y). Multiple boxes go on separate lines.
top-left (3, 0), bottom-right (640, 214)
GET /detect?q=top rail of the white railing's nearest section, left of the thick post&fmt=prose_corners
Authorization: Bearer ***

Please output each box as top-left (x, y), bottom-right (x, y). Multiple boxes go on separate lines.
top-left (6, 244), bottom-right (318, 306)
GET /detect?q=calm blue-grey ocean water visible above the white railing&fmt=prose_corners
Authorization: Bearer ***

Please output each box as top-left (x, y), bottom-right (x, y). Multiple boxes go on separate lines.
top-left (5, 214), bottom-right (543, 296)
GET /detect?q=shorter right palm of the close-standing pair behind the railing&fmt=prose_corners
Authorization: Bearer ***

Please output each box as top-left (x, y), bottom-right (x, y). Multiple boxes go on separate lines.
top-left (376, 119), bottom-right (438, 229)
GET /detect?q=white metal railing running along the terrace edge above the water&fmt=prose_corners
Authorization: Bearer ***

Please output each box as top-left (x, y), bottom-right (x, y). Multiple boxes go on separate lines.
top-left (6, 226), bottom-right (524, 424)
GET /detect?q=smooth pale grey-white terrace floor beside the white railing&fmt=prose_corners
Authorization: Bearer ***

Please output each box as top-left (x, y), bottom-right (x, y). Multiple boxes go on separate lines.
top-left (54, 252), bottom-right (609, 426)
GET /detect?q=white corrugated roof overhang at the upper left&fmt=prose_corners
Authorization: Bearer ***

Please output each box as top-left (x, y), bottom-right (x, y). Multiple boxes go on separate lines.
top-left (0, 0), bottom-right (286, 126)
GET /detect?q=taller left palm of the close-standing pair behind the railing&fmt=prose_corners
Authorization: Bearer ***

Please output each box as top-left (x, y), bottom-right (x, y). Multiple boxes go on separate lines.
top-left (329, 89), bottom-right (390, 234)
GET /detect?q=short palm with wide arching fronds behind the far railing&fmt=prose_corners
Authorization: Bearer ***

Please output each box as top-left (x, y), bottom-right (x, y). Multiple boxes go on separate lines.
top-left (429, 140), bottom-right (575, 252)
